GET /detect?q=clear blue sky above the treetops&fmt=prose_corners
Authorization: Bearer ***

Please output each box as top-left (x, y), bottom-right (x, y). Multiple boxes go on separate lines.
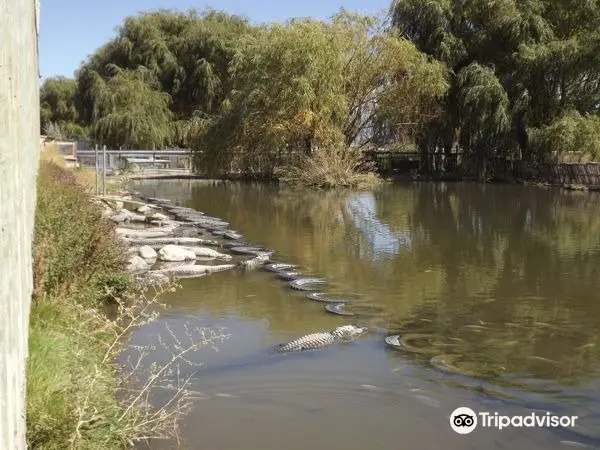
top-left (40, 0), bottom-right (391, 78)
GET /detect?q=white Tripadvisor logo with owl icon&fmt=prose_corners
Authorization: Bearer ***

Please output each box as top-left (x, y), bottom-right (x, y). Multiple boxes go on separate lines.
top-left (450, 406), bottom-right (578, 434)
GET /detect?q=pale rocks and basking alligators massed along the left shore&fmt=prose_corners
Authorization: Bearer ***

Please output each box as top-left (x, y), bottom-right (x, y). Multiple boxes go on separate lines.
top-left (93, 193), bottom-right (273, 284)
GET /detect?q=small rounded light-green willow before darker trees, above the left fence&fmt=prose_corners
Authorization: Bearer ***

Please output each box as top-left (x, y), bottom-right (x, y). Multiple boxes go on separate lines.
top-left (92, 68), bottom-right (173, 148)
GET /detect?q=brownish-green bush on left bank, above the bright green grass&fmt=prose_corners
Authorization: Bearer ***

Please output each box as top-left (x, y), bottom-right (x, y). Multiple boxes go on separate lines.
top-left (34, 161), bottom-right (129, 306)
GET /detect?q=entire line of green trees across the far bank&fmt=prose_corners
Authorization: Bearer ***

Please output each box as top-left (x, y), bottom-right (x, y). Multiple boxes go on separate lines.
top-left (42, 0), bottom-right (600, 185)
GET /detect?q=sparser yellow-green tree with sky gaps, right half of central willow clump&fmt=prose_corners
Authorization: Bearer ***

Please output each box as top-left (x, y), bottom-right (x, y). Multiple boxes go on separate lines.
top-left (331, 11), bottom-right (449, 146)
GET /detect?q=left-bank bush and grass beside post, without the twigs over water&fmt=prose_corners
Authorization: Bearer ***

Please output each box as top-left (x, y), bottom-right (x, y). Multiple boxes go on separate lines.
top-left (27, 159), bottom-right (133, 450)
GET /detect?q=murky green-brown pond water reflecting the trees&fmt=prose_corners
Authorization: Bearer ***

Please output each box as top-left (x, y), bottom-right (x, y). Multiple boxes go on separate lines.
top-left (127, 181), bottom-right (600, 450)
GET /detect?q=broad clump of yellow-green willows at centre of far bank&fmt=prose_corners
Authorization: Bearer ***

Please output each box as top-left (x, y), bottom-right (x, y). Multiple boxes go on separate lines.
top-left (194, 11), bottom-right (448, 179)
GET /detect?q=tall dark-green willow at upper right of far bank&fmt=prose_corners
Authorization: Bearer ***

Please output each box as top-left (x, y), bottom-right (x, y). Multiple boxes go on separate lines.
top-left (390, 0), bottom-right (600, 174)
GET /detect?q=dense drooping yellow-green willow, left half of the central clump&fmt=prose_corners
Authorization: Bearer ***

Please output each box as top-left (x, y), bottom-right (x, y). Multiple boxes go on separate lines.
top-left (197, 15), bottom-right (346, 174)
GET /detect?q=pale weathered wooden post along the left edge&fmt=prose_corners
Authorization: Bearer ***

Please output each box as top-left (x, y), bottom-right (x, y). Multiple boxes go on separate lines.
top-left (0, 0), bottom-right (41, 450)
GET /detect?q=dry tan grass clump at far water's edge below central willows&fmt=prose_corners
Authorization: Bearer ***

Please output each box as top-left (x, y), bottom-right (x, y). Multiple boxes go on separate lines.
top-left (280, 146), bottom-right (381, 189)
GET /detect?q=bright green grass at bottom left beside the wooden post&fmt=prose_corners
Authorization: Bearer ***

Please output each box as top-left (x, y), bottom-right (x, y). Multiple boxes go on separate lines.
top-left (27, 300), bottom-right (123, 450)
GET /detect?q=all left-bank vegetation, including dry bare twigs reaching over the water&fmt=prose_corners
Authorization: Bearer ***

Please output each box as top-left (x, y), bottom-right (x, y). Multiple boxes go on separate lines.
top-left (27, 159), bottom-right (224, 450)
